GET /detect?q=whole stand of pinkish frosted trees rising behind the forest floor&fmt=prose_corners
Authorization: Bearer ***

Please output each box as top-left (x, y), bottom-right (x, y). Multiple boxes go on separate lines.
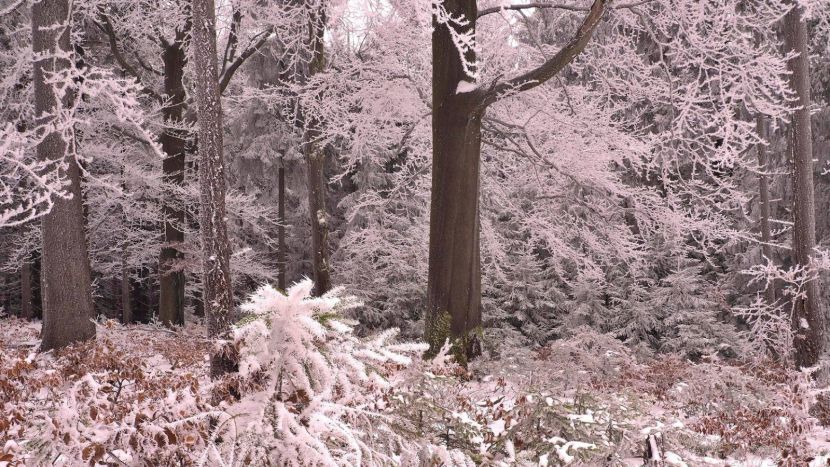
top-left (0, 0), bottom-right (828, 366)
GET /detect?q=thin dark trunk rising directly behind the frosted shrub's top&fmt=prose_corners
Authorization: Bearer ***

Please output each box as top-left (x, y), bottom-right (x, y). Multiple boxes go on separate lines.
top-left (303, 0), bottom-right (331, 296)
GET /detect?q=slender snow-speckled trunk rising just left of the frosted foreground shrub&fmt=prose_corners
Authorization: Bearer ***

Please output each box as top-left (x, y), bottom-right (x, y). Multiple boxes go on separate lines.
top-left (191, 0), bottom-right (235, 378)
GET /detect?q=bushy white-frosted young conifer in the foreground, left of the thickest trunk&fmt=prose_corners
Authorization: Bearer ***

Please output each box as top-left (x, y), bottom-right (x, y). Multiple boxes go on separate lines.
top-left (203, 280), bottom-right (426, 466)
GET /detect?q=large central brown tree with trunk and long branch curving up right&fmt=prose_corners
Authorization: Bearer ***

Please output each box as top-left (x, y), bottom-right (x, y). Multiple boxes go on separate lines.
top-left (425, 0), bottom-right (607, 361)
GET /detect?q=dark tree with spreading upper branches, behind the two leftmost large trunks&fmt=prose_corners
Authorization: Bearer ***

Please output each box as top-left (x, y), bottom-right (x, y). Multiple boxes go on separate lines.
top-left (88, 0), bottom-right (271, 326)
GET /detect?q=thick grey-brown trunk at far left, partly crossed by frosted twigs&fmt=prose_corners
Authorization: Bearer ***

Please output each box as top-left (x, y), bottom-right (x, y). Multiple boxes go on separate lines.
top-left (32, 0), bottom-right (95, 350)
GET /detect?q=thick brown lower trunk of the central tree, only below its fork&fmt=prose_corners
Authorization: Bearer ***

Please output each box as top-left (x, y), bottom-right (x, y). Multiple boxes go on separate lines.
top-left (426, 96), bottom-right (482, 361)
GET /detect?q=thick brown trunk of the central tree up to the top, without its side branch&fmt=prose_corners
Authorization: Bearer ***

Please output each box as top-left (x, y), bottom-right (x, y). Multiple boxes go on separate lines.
top-left (425, 0), bottom-right (484, 362)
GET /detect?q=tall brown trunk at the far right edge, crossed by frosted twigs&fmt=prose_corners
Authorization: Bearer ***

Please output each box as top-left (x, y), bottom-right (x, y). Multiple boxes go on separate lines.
top-left (784, 2), bottom-right (825, 368)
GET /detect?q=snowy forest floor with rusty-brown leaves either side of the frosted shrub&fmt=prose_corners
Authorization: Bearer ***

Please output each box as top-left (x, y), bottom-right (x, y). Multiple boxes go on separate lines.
top-left (0, 318), bottom-right (830, 467)
